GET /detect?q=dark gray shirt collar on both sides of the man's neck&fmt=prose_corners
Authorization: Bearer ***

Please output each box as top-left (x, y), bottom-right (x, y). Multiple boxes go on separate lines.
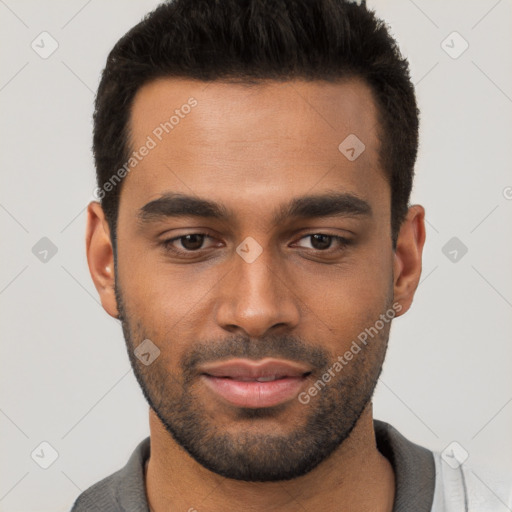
top-left (71, 420), bottom-right (436, 512)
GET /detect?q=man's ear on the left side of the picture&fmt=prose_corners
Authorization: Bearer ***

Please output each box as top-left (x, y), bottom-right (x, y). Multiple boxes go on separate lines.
top-left (85, 201), bottom-right (119, 318)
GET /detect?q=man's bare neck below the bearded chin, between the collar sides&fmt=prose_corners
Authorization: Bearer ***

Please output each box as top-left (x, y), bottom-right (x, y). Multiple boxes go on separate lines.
top-left (146, 403), bottom-right (395, 512)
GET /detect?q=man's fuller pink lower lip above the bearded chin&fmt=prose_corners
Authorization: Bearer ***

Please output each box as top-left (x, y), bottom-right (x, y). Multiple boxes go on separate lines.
top-left (202, 375), bottom-right (306, 409)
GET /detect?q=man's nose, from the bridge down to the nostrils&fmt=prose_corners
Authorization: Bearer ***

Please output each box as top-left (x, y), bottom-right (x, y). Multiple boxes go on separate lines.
top-left (215, 242), bottom-right (300, 337)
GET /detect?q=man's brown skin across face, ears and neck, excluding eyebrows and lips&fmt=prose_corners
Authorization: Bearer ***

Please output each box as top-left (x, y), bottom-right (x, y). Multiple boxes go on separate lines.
top-left (86, 79), bottom-right (425, 512)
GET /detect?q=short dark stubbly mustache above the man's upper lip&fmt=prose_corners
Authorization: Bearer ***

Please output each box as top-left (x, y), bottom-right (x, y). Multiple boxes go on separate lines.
top-left (180, 334), bottom-right (331, 377)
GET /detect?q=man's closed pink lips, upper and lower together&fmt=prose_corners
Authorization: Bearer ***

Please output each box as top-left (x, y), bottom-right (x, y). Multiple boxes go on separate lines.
top-left (201, 359), bottom-right (311, 409)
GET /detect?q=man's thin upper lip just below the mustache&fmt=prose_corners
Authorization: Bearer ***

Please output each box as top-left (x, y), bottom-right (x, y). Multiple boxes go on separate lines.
top-left (200, 358), bottom-right (311, 379)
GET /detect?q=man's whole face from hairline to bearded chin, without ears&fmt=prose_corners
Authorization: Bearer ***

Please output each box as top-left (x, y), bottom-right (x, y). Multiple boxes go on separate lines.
top-left (116, 79), bottom-right (400, 481)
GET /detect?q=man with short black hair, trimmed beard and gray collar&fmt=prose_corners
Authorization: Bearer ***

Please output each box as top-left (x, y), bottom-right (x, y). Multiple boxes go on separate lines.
top-left (73, 0), bottom-right (508, 512)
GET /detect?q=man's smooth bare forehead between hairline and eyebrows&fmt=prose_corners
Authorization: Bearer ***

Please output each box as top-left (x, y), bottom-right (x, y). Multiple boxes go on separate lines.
top-left (121, 78), bottom-right (389, 217)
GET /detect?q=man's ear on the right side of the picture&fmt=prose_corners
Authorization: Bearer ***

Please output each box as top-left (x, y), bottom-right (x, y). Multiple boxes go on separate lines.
top-left (393, 204), bottom-right (425, 316)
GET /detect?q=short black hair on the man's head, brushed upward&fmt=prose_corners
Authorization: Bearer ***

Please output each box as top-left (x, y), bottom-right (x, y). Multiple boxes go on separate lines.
top-left (93, 0), bottom-right (419, 251)
